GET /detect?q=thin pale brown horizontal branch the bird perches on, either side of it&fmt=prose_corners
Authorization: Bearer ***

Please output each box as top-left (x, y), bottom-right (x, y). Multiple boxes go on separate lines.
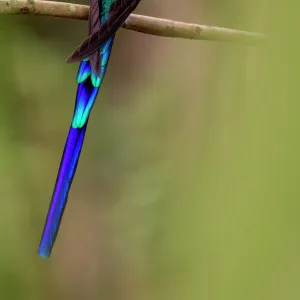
top-left (0, 0), bottom-right (266, 45)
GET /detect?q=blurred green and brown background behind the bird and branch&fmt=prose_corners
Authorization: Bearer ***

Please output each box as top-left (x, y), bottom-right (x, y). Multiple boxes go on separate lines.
top-left (0, 0), bottom-right (300, 300)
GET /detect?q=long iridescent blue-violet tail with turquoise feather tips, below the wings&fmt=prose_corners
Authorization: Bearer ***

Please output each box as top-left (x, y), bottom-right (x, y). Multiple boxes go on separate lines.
top-left (38, 37), bottom-right (114, 258)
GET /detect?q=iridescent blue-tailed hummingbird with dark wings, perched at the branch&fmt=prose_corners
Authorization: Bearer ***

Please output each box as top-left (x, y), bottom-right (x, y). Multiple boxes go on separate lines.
top-left (38, 0), bottom-right (140, 258)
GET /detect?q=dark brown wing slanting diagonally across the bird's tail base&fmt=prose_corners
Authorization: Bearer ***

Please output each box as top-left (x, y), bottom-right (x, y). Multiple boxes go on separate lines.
top-left (67, 0), bottom-right (141, 62)
